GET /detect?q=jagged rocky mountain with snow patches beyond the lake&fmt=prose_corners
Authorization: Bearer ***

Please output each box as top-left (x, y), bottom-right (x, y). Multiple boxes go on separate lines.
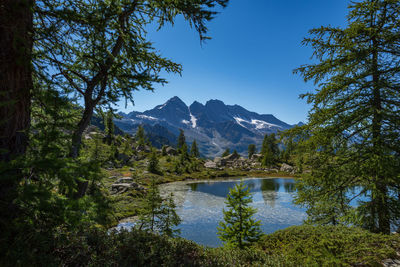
top-left (115, 96), bottom-right (293, 157)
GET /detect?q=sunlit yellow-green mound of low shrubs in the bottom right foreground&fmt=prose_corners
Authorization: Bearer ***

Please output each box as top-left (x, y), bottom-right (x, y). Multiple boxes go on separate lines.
top-left (258, 225), bottom-right (400, 266)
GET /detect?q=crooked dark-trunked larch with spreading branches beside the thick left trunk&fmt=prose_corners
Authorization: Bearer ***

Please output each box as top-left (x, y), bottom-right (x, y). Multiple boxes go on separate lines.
top-left (34, 0), bottom-right (228, 198)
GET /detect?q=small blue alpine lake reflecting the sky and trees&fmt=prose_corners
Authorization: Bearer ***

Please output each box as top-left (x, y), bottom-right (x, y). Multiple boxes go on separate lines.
top-left (118, 178), bottom-right (306, 247)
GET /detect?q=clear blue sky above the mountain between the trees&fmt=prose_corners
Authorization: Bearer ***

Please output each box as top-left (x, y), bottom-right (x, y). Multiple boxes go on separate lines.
top-left (118, 0), bottom-right (350, 124)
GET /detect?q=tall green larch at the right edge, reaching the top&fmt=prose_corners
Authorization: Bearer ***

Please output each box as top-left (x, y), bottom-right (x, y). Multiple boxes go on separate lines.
top-left (291, 0), bottom-right (400, 234)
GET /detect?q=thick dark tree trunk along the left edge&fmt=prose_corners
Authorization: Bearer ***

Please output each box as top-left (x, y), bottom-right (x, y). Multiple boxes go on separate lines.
top-left (0, 0), bottom-right (33, 223)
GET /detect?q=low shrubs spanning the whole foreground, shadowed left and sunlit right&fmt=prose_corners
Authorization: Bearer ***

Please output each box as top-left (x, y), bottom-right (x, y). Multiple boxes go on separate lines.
top-left (0, 226), bottom-right (400, 266)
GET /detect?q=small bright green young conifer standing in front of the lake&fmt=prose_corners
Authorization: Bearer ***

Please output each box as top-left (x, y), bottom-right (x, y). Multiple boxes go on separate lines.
top-left (218, 181), bottom-right (261, 249)
